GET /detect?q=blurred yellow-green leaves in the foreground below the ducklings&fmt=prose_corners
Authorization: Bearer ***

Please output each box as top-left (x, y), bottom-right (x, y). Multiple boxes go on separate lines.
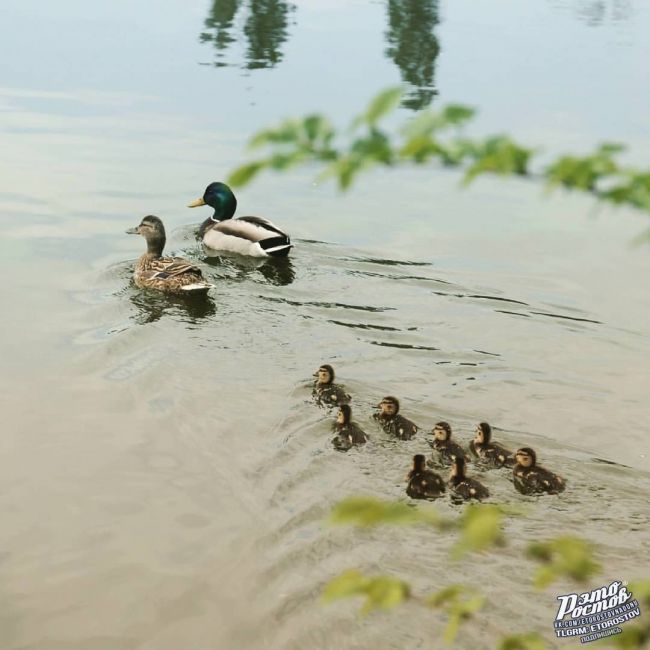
top-left (323, 497), bottom-right (650, 650)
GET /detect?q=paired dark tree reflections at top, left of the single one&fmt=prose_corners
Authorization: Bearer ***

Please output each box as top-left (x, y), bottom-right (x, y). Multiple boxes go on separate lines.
top-left (200, 0), bottom-right (295, 70)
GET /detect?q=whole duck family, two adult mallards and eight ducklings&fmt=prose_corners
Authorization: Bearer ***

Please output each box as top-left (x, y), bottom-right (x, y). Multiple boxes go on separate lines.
top-left (126, 187), bottom-right (566, 500)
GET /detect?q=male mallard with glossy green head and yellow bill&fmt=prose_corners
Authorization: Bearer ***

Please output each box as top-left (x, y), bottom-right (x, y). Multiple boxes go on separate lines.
top-left (187, 183), bottom-right (291, 257)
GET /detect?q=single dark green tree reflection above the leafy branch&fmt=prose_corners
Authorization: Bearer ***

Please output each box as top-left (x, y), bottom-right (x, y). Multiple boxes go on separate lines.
top-left (386, 0), bottom-right (440, 111)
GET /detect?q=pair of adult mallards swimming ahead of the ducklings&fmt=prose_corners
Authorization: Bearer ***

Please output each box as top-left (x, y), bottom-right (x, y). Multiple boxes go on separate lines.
top-left (126, 182), bottom-right (292, 295)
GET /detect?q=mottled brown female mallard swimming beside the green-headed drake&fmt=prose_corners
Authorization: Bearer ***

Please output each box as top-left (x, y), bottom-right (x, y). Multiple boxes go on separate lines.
top-left (126, 215), bottom-right (212, 294)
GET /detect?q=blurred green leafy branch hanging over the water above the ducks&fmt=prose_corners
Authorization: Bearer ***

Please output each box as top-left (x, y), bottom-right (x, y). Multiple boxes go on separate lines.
top-left (228, 88), bottom-right (650, 219)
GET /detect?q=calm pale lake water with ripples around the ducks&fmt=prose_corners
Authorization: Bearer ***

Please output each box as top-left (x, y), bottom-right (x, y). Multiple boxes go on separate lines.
top-left (0, 0), bottom-right (650, 650)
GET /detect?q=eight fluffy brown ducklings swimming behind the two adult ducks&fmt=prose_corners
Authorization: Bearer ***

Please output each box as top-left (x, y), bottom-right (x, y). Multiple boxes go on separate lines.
top-left (312, 364), bottom-right (565, 499)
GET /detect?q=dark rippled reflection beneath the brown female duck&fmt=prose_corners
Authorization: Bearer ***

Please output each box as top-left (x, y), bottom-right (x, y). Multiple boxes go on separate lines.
top-left (129, 289), bottom-right (217, 325)
